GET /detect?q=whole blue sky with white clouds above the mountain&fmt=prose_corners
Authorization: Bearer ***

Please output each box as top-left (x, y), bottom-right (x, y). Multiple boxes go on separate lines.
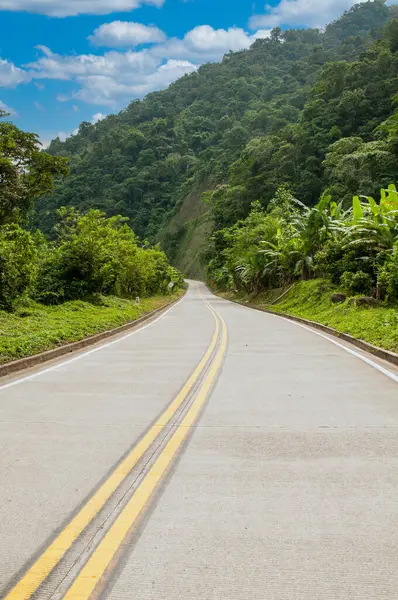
top-left (0, 0), bottom-right (370, 142)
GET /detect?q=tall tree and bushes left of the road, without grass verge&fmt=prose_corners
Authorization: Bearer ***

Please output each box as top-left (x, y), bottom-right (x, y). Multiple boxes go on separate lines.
top-left (0, 110), bottom-right (182, 312)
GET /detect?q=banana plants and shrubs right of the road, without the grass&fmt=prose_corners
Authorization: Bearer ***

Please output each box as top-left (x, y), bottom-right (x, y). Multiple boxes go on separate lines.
top-left (207, 185), bottom-right (398, 300)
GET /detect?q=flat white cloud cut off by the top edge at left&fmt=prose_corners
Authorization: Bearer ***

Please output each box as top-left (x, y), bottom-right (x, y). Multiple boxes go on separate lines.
top-left (0, 0), bottom-right (164, 17)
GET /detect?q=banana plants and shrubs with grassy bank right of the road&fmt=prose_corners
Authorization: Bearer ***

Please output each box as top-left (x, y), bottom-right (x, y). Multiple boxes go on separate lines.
top-left (208, 185), bottom-right (398, 352)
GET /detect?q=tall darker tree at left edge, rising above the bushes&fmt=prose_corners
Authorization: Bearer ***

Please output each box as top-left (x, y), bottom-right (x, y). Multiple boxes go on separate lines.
top-left (0, 109), bottom-right (67, 225)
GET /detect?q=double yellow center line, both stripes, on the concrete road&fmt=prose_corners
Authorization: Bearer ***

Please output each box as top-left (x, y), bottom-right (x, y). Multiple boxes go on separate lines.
top-left (4, 296), bottom-right (227, 600)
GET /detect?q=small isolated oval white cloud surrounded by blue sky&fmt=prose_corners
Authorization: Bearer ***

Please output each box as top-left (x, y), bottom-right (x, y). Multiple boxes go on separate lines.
top-left (89, 21), bottom-right (166, 48)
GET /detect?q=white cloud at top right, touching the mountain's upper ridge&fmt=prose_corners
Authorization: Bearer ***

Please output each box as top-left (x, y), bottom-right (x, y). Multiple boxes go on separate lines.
top-left (250, 0), bottom-right (364, 29)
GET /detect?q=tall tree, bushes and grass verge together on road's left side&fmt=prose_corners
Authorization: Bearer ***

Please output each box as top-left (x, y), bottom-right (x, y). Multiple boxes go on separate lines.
top-left (0, 109), bottom-right (184, 363)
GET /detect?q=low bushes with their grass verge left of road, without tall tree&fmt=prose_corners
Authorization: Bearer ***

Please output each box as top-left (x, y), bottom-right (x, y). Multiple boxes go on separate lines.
top-left (0, 210), bottom-right (184, 363)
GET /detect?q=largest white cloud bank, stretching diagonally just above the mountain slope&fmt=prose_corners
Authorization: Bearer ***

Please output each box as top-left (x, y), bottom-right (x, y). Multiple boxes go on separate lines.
top-left (22, 24), bottom-right (270, 108)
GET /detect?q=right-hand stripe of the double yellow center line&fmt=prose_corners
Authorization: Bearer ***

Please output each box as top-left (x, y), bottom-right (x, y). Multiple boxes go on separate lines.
top-left (63, 315), bottom-right (227, 600)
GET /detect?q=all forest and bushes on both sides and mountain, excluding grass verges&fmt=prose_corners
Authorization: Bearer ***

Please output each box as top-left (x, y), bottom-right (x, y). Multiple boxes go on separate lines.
top-left (0, 0), bottom-right (398, 309)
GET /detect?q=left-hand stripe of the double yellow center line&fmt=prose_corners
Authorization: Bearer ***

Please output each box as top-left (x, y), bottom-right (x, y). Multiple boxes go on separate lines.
top-left (4, 302), bottom-right (220, 600)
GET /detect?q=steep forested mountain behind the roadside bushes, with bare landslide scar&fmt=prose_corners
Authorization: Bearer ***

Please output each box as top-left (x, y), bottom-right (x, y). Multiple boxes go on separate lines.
top-left (39, 0), bottom-right (398, 274)
